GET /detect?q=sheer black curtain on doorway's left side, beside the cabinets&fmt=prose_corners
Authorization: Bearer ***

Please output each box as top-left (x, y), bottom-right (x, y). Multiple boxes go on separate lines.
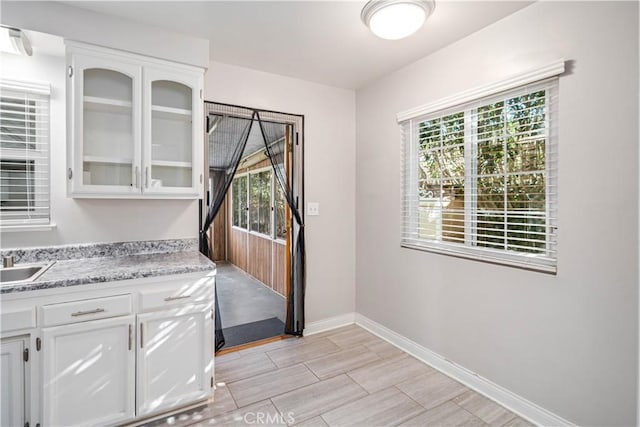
top-left (199, 103), bottom-right (256, 351)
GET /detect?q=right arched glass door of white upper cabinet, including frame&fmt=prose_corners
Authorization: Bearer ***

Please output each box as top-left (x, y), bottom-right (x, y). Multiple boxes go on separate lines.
top-left (143, 69), bottom-right (203, 195)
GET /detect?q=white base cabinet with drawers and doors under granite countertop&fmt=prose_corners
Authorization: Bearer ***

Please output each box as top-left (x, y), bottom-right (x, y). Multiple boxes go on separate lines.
top-left (1, 273), bottom-right (215, 427)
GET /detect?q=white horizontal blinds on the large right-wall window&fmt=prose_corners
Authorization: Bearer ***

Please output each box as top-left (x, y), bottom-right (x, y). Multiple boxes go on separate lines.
top-left (400, 78), bottom-right (558, 271)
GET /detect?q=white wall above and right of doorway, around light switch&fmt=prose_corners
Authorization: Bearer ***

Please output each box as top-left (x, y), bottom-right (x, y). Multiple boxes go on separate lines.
top-left (205, 62), bottom-right (355, 322)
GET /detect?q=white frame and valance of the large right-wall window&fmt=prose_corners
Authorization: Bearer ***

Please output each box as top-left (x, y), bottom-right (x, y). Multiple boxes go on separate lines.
top-left (398, 60), bottom-right (564, 274)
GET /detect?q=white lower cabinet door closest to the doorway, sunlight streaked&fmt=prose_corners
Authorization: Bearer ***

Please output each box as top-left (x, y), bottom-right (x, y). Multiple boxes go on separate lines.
top-left (136, 304), bottom-right (213, 416)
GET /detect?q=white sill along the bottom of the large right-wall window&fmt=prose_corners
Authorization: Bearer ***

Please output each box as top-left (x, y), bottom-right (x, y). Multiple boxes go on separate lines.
top-left (400, 243), bottom-right (558, 275)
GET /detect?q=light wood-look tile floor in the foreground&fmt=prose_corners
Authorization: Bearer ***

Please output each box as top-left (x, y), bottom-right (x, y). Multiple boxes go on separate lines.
top-left (149, 326), bottom-right (531, 427)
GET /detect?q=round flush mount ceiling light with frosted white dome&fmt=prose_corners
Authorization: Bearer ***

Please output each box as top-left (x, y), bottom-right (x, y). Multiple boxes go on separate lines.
top-left (360, 0), bottom-right (436, 40)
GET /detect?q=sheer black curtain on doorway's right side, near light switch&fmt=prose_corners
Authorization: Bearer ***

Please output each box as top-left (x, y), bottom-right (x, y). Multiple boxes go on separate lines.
top-left (256, 111), bottom-right (306, 335)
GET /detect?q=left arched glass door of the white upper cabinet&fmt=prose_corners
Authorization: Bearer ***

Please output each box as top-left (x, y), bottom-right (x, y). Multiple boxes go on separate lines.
top-left (74, 56), bottom-right (141, 194)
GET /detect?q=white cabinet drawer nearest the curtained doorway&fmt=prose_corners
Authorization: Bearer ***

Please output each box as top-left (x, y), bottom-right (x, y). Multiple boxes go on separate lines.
top-left (140, 278), bottom-right (214, 311)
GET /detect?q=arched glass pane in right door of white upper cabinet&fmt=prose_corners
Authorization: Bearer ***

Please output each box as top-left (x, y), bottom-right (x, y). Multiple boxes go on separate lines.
top-left (149, 80), bottom-right (193, 188)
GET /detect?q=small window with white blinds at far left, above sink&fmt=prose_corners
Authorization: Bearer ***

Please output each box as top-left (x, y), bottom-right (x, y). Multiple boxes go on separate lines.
top-left (0, 79), bottom-right (50, 230)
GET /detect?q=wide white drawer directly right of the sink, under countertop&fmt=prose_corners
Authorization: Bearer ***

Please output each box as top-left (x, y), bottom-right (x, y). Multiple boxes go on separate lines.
top-left (40, 294), bottom-right (132, 326)
